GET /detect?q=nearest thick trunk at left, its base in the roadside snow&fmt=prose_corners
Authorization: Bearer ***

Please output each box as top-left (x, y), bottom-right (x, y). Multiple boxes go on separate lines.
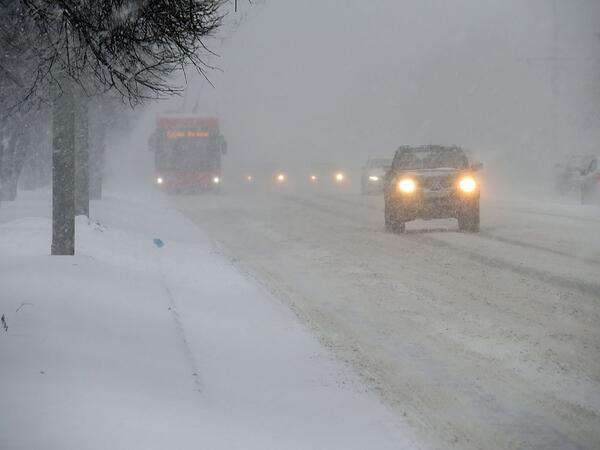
top-left (51, 81), bottom-right (75, 255)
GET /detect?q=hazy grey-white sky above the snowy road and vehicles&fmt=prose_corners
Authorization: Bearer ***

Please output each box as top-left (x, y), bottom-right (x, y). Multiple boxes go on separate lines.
top-left (148, 0), bottom-right (600, 178)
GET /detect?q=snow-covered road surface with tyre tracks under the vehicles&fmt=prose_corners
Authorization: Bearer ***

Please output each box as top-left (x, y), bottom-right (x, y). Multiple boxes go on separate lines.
top-left (172, 192), bottom-right (600, 450)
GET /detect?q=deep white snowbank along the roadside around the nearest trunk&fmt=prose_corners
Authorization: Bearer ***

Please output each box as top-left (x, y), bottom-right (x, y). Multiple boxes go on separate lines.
top-left (0, 193), bottom-right (415, 450)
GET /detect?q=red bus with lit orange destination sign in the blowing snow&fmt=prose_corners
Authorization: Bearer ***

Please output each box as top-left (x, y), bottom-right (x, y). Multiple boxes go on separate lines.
top-left (150, 115), bottom-right (227, 193)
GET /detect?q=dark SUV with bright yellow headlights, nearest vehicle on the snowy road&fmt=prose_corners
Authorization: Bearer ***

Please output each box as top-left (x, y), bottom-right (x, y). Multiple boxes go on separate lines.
top-left (384, 145), bottom-right (482, 233)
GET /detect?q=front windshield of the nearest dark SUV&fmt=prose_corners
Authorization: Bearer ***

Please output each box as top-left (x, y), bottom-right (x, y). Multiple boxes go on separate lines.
top-left (394, 149), bottom-right (468, 170)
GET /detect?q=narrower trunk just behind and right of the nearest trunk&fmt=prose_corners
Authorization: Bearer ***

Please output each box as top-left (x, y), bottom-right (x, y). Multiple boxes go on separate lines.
top-left (75, 98), bottom-right (90, 217)
